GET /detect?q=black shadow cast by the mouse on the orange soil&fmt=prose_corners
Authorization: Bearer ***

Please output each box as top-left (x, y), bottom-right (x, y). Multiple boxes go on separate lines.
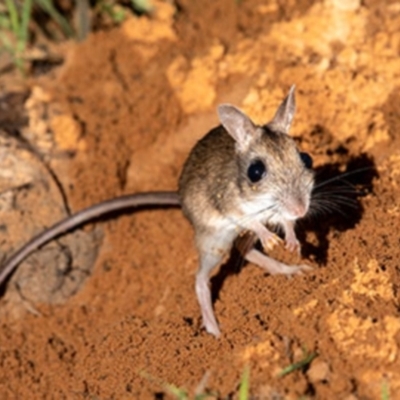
top-left (210, 154), bottom-right (379, 303)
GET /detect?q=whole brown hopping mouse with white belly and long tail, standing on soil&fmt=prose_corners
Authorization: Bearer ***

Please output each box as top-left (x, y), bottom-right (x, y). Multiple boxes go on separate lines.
top-left (0, 86), bottom-right (314, 337)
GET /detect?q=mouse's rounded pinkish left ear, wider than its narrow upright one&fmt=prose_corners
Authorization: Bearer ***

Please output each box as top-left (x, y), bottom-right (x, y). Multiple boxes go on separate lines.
top-left (218, 104), bottom-right (257, 151)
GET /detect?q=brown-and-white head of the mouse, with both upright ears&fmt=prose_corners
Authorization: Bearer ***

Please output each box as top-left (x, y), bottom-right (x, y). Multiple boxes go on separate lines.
top-left (218, 86), bottom-right (314, 223)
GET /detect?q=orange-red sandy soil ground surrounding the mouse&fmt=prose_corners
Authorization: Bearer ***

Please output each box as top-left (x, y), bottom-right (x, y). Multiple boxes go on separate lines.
top-left (0, 0), bottom-right (400, 400)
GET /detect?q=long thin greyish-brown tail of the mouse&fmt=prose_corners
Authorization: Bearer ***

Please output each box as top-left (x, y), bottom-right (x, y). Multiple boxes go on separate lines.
top-left (0, 192), bottom-right (180, 286)
